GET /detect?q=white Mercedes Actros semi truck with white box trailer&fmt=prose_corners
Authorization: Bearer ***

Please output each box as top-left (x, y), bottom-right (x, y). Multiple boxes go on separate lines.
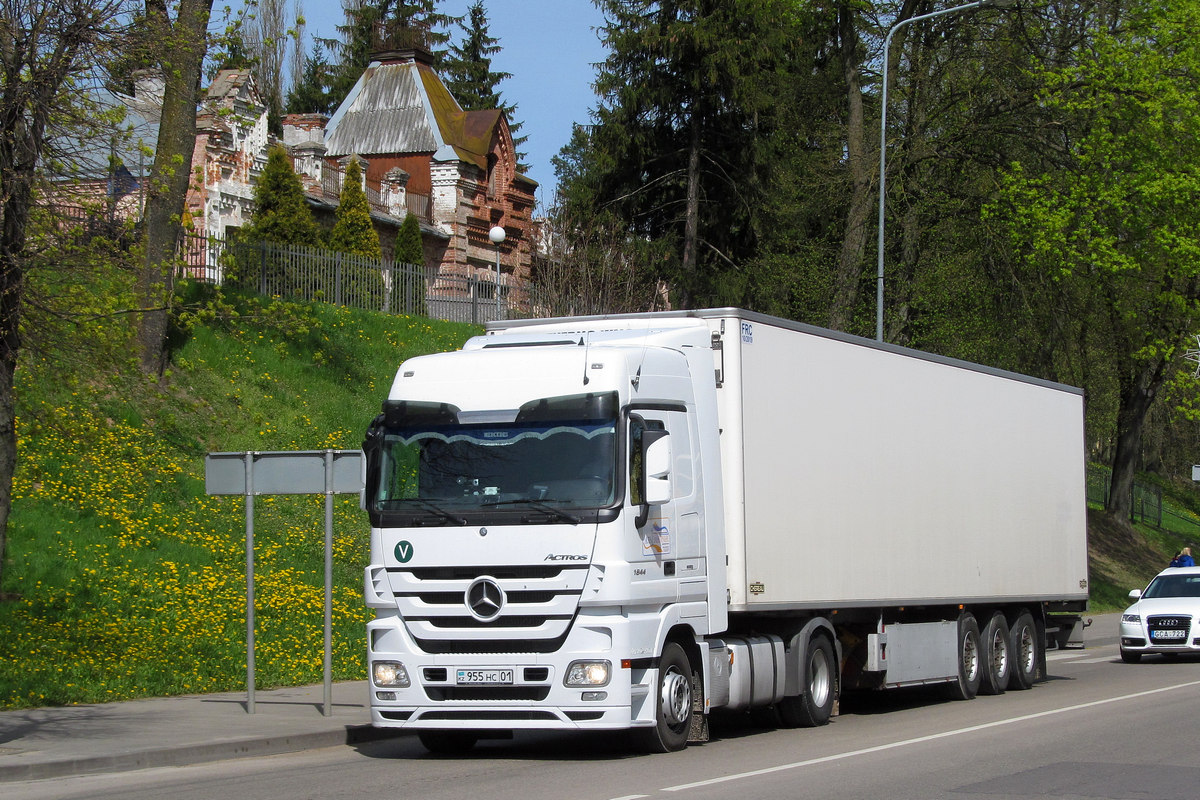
top-left (364, 308), bottom-right (1087, 751)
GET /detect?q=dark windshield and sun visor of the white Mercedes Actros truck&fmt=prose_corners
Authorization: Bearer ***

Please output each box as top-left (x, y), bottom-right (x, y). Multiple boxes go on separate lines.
top-left (366, 393), bottom-right (617, 523)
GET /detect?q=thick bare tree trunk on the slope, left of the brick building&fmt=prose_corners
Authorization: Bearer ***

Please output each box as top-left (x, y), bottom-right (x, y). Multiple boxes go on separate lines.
top-left (138, 0), bottom-right (212, 375)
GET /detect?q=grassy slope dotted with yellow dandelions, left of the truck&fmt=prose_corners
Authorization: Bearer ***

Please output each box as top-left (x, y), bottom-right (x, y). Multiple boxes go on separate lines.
top-left (0, 292), bottom-right (478, 708)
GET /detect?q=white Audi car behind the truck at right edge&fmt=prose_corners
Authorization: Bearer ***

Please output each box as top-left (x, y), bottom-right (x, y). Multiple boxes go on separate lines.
top-left (1121, 566), bottom-right (1200, 663)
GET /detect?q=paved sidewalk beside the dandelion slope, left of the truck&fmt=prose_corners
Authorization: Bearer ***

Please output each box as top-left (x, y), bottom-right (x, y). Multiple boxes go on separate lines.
top-left (0, 681), bottom-right (396, 794)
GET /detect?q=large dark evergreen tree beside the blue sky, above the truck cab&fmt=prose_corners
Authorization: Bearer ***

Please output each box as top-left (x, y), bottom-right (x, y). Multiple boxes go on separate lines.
top-left (564, 0), bottom-right (798, 306)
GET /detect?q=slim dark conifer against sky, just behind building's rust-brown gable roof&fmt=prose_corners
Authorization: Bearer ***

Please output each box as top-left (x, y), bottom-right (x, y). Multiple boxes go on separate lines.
top-left (442, 0), bottom-right (529, 172)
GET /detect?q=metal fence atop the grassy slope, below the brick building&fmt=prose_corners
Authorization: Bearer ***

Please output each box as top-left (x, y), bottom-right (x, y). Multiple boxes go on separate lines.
top-left (182, 236), bottom-right (534, 325)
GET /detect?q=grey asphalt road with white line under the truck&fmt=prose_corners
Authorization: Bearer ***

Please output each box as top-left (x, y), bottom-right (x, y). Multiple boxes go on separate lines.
top-left (4, 618), bottom-right (1200, 800)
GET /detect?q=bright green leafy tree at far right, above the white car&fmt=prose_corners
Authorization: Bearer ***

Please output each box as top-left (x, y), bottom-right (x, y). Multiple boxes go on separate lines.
top-left (991, 0), bottom-right (1200, 524)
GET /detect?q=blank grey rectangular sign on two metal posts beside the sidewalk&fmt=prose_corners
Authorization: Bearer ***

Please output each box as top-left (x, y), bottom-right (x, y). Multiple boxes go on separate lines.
top-left (204, 450), bottom-right (362, 716)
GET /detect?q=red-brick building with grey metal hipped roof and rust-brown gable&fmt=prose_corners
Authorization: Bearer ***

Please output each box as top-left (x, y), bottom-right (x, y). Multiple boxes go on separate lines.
top-left (283, 38), bottom-right (536, 302)
